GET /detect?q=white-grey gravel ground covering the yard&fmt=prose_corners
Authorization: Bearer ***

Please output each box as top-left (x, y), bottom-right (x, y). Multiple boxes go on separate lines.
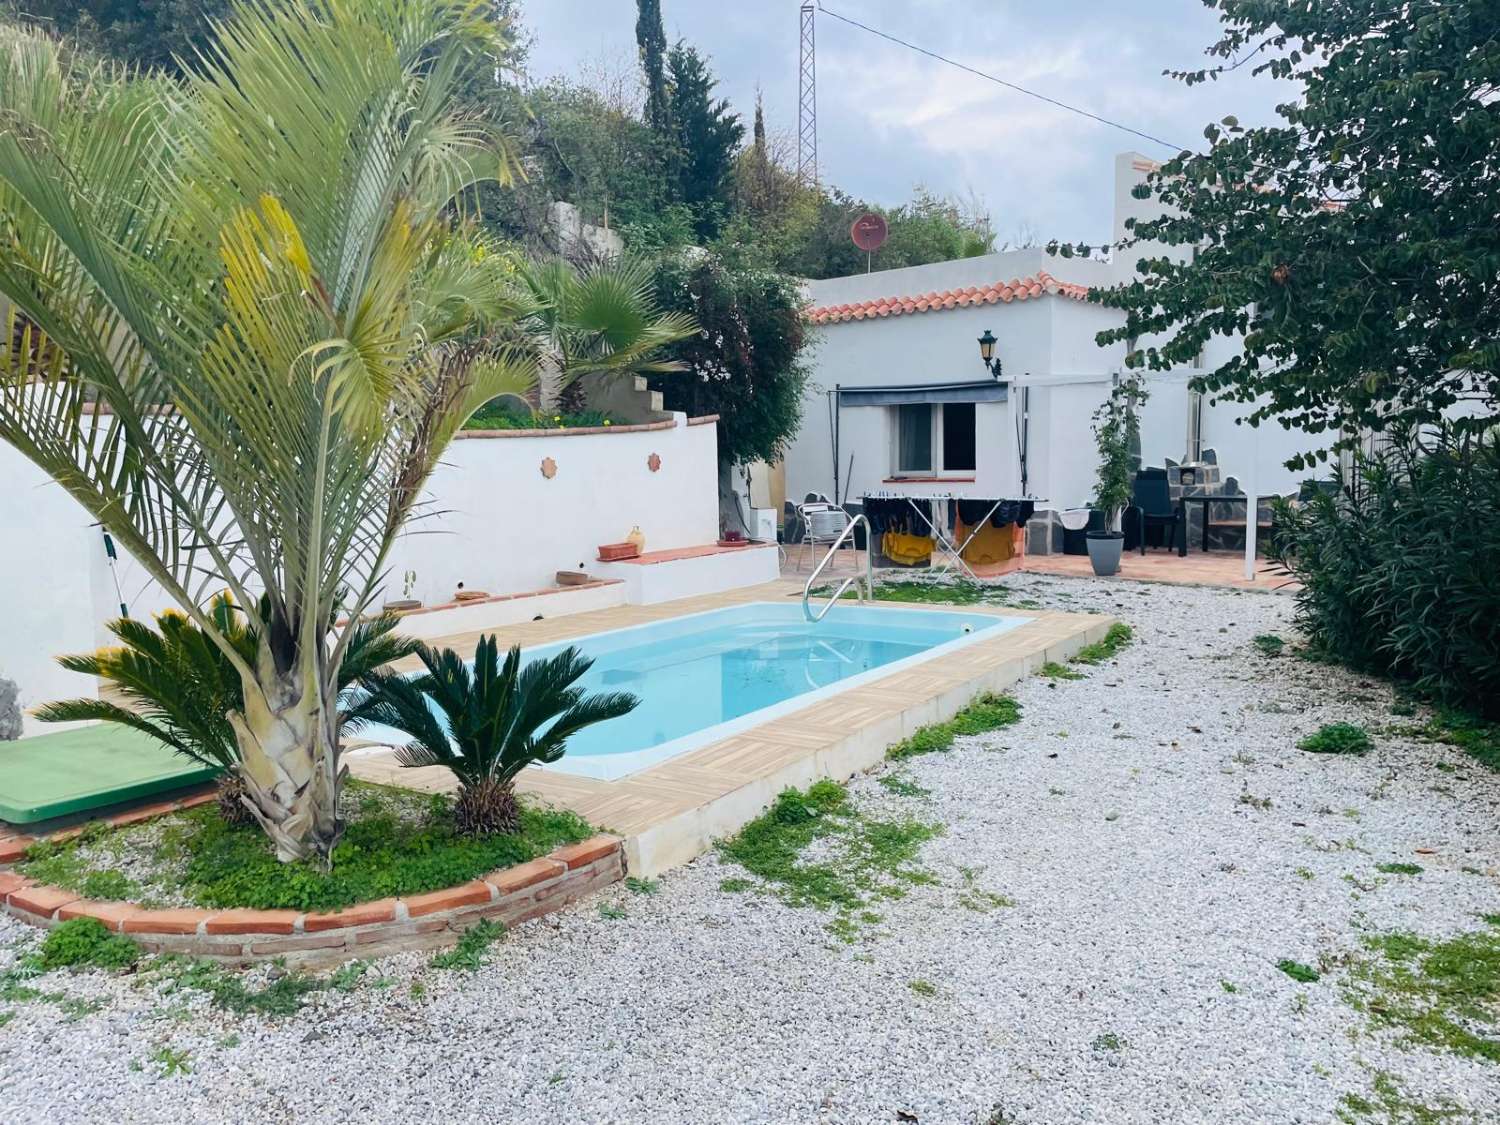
top-left (0, 576), bottom-right (1500, 1125)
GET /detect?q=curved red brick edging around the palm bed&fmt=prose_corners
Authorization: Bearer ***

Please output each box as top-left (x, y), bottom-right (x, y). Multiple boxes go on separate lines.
top-left (0, 836), bottom-right (626, 963)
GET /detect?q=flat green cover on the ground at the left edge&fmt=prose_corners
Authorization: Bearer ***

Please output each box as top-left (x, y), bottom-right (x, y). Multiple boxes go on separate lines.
top-left (0, 723), bottom-right (218, 824)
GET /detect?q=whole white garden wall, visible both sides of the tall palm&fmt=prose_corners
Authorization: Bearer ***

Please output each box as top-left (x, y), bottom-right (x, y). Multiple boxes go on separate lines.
top-left (0, 414), bottom-right (719, 735)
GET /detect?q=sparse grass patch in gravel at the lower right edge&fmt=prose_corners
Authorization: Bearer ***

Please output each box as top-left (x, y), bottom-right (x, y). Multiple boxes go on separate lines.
top-left (1347, 930), bottom-right (1500, 1062)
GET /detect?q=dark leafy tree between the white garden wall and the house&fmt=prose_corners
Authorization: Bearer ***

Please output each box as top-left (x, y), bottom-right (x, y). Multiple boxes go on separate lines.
top-left (653, 252), bottom-right (807, 465)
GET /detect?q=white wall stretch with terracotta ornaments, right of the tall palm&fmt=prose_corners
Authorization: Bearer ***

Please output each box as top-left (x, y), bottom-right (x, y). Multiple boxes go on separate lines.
top-left (387, 414), bottom-right (719, 605)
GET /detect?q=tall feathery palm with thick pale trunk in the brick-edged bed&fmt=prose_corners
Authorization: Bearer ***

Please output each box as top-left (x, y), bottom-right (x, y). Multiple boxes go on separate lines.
top-left (0, 0), bottom-right (536, 864)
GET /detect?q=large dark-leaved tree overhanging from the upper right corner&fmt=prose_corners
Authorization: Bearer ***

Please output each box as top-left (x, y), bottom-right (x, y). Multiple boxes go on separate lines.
top-left (1095, 0), bottom-right (1500, 468)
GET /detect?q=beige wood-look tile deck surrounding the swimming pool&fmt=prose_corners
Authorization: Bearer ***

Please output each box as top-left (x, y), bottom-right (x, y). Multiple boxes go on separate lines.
top-left (345, 581), bottom-right (1113, 876)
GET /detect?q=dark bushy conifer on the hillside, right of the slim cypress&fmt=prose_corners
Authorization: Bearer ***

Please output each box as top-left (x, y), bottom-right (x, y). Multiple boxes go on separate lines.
top-left (668, 41), bottom-right (746, 239)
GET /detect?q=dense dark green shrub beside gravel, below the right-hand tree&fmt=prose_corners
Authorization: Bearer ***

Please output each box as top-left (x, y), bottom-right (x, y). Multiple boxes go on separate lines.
top-left (1274, 429), bottom-right (1500, 719)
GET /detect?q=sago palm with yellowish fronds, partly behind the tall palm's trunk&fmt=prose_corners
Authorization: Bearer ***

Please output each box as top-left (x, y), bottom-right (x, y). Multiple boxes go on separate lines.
top-left (33, 594), bottom-right (422, 824)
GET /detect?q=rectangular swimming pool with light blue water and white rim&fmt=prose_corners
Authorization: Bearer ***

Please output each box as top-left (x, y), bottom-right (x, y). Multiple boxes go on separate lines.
top-left (362, 602), bottom-right (1028, 780)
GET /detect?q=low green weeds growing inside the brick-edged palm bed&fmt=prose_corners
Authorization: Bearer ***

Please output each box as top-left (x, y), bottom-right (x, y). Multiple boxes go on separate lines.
top-left (18, 782), bottom-right (594, 911)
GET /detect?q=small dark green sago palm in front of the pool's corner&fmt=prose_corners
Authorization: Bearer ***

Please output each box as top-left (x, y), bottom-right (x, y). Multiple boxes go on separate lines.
top-left (351, 636), bottom-right (641, 836)
